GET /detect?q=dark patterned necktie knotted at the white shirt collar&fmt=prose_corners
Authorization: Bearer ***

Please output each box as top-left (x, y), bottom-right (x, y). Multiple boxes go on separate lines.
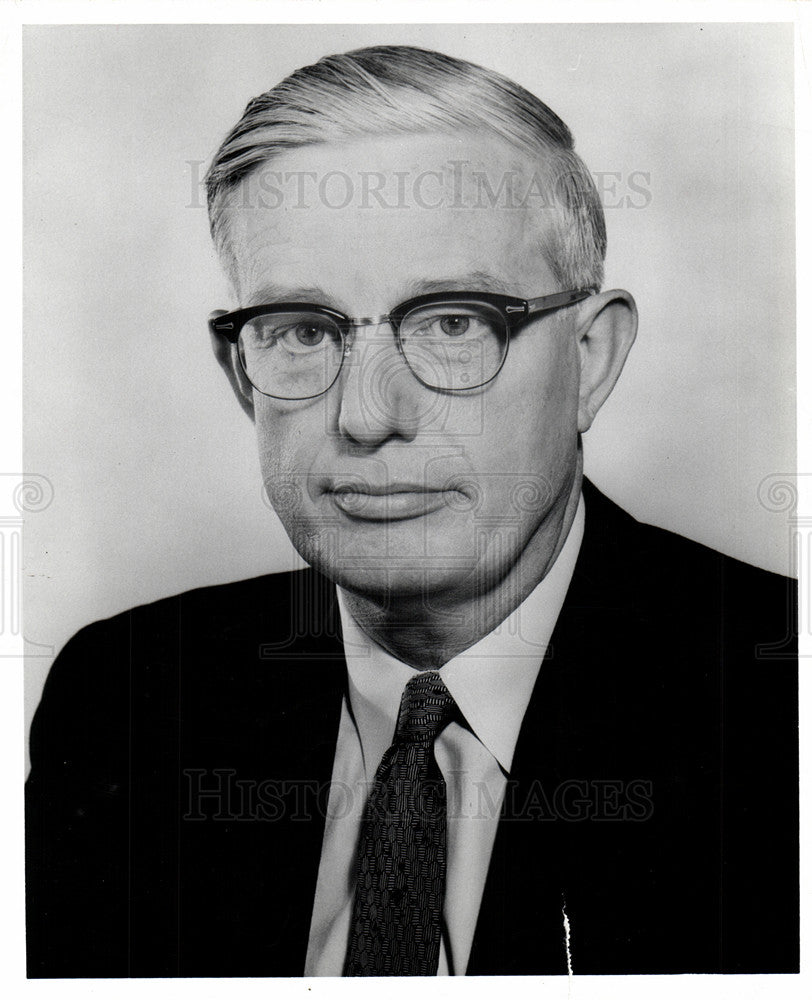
top-left (344, 670), bottom-right (455, 976)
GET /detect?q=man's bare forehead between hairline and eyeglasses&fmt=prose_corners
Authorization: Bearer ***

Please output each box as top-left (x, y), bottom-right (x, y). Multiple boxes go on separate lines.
top-left (224, 135), bottom-right (554, 314)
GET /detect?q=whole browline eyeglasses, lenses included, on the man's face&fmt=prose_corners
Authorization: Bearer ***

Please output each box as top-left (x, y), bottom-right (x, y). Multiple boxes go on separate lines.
top-left (209, 290), bottom-right (593, 400)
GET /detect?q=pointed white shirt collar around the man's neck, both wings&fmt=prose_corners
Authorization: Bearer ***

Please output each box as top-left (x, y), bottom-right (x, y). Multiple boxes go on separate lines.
top-left (336, 496), bottom-right (584, 781)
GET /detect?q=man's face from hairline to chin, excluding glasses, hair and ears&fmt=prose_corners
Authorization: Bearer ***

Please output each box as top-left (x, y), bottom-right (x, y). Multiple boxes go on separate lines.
top-left (228, 135), bottom-right (579, 602)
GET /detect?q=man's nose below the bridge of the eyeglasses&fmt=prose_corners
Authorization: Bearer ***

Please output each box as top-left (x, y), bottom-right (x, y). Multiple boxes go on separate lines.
top-left (337, 321), bottom-right (426, 447)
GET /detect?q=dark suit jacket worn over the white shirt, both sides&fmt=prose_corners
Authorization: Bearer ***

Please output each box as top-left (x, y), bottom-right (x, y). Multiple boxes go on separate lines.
top-left (27, 483), bottom-right (799, 977)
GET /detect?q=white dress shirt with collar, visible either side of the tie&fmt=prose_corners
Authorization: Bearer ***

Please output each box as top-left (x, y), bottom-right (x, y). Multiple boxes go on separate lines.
top-left (305, 497), bottom-right (584, 976)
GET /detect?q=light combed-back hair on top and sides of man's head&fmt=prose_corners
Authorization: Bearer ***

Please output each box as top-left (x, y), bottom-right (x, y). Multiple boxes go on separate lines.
top-left (206, 45), bottom-right (606, 291)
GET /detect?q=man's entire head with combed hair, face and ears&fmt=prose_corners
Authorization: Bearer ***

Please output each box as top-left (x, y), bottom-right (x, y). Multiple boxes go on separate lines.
top-left (207, 47), bottom-right (635, 604)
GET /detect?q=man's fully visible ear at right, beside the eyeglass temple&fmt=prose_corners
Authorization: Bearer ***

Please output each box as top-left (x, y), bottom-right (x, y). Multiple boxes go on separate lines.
top-left (576, 289), bottom-right (637, 434)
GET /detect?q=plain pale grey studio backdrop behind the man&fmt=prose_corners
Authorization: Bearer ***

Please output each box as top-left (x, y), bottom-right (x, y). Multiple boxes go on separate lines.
top-left (23, 24), bottom-right (795, 740)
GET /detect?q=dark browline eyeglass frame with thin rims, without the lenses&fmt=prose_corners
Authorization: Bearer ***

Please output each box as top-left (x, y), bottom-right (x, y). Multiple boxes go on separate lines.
top-left (209, 289), bottom-right (595, 400)
